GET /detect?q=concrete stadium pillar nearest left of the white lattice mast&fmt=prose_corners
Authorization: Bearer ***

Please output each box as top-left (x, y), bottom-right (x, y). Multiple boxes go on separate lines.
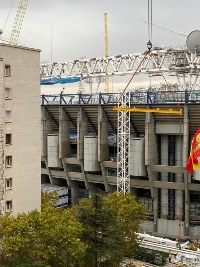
top-left (98, 106), bottom-right (109, 192)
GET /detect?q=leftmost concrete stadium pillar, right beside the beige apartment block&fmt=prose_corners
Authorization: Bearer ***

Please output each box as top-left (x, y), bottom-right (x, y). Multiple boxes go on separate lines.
top-left (41, 107), bottom-right (52, 183)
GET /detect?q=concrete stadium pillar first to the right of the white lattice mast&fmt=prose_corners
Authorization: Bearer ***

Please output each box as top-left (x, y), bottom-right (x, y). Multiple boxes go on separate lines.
top-left (145, 113), bottom-right (158, 232)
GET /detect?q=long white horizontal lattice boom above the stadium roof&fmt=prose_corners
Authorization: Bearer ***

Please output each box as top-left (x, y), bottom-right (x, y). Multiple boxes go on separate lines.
top-left (40, 48), bottom-right (200, 90)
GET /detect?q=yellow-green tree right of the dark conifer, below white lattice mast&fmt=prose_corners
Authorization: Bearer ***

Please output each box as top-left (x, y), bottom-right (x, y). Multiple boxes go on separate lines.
top-left (105, 192), bottom-right (147, 256)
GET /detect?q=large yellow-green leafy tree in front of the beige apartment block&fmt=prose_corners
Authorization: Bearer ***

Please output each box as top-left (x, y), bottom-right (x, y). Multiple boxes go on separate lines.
top-left (0, 193), bottom-right (85, 267)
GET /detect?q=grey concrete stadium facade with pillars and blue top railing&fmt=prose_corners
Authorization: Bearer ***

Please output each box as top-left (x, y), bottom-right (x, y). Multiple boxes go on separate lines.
top-left (41, 90), bottom-right (200, 238)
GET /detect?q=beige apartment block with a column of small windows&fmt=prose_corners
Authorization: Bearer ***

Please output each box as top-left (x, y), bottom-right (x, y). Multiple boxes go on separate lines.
top-left (0, 44), bottom-right (41, 215)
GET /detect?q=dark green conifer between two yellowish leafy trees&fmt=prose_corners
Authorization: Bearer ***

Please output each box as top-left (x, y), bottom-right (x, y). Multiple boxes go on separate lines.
top-left (75, 194), bottom-right (123, 267)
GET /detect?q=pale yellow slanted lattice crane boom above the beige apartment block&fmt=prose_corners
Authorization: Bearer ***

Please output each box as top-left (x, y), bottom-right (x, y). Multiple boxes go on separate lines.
top-left (9, 0), bottom-right (28, 45)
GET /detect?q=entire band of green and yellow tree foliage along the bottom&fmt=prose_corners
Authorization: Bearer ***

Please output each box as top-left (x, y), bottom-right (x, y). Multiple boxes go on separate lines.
top-left (0, 193), bottom-right (146, 267)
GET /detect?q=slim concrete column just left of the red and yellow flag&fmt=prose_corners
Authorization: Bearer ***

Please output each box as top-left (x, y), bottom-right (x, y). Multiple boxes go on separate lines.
top-left (183, 105), bottom-right (190, 236)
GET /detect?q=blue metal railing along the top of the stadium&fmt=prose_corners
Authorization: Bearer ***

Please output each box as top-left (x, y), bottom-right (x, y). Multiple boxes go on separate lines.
top-left (41, 90), bottom-right (200, 106)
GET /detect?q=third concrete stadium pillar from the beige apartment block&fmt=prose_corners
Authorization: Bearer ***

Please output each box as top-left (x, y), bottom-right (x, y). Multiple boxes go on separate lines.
top-left (77, 107), bottom-right (88, 189)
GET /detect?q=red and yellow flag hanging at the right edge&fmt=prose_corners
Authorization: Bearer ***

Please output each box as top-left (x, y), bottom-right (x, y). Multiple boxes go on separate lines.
top-left (186, 128), bottom-right (200, 172)
